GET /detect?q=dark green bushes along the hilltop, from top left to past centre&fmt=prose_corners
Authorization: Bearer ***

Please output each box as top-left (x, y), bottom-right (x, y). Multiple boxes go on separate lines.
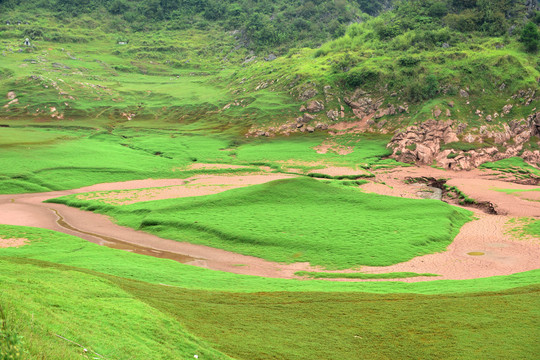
top-left (0, 0), bottom-right (368, 52)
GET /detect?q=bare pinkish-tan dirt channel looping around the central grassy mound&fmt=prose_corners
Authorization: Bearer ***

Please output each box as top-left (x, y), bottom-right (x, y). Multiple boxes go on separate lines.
top-left (0, 167), bottom-right (540, 282)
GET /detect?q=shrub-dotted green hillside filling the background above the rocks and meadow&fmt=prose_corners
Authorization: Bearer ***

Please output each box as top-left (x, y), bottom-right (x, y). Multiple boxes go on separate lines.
top-left (0, 0), bottom-right (540, 128)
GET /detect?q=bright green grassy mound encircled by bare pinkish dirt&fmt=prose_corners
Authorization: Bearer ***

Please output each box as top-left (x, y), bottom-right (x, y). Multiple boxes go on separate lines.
top-left (49, 178), bottom-right (470, 269)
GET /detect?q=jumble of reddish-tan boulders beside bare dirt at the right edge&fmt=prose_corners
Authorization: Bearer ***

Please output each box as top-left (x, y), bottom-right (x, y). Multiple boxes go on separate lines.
top-left (388, 112), bottom-right (540, 170)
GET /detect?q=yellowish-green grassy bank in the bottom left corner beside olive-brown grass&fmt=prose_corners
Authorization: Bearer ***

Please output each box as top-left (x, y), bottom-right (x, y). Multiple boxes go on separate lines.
top-left (0, 259), bottom-right (228, 359)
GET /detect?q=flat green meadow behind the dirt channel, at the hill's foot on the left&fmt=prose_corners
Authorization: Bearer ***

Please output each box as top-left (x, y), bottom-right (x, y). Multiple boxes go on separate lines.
top-left (0, 124), bottom-right (399, 194)
